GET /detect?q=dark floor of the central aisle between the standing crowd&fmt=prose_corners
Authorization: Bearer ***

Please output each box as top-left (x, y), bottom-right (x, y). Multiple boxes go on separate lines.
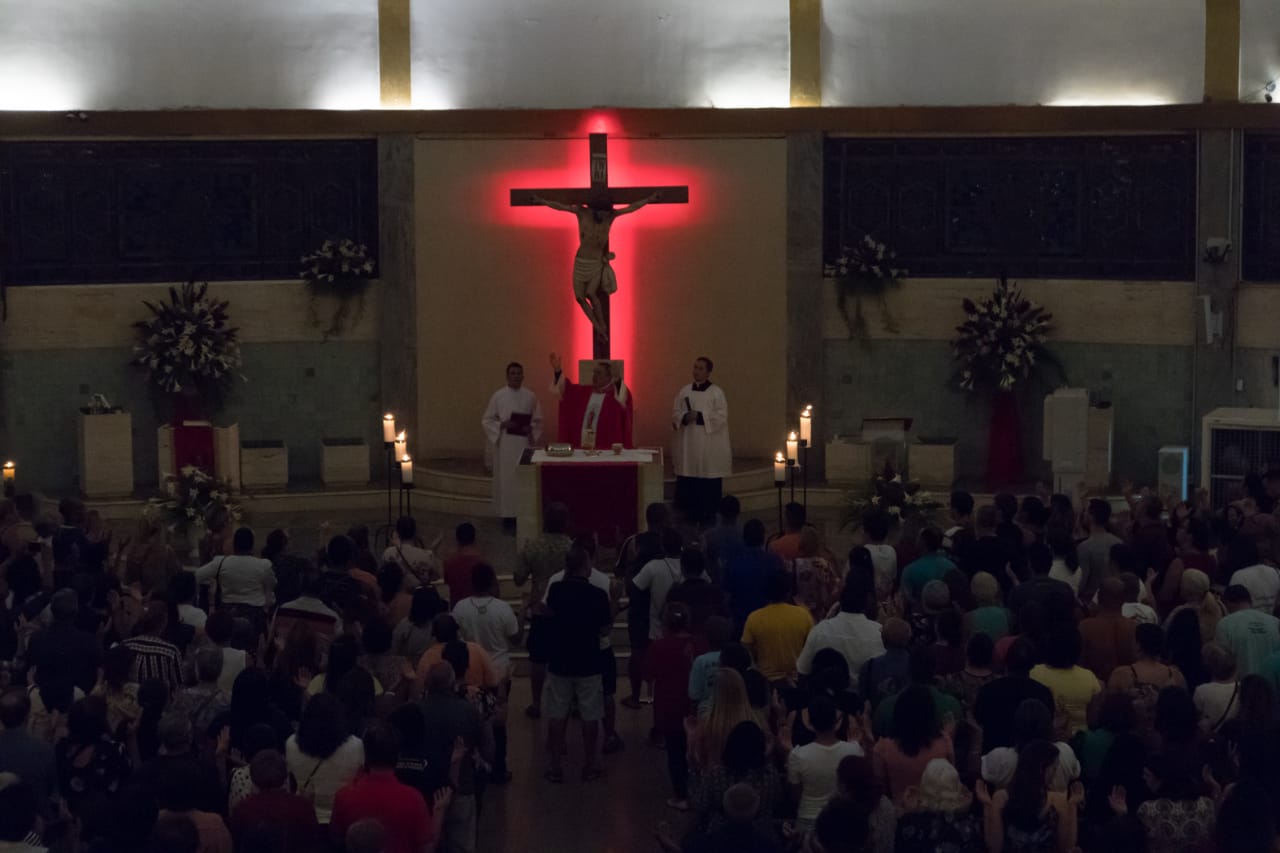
top-left (477, 678), bottom-right (685, 853)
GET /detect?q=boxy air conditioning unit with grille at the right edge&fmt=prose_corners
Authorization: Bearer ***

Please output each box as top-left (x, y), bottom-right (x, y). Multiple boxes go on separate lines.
top-left (1201, 409), bottom-right (1280, 508)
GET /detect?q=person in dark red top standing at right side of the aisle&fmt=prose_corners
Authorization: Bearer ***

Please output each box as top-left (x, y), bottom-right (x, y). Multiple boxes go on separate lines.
top-left (644, 602), bottom-right (708, 812)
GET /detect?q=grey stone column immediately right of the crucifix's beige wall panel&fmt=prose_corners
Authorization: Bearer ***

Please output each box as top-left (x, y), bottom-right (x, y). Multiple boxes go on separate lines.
top-left (778, 133), bottom-right (827, 484)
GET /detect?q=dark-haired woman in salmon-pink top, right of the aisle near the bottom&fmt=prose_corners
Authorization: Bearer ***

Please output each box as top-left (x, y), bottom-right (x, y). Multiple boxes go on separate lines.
top-left (872, 684), bottom-right (956, 803)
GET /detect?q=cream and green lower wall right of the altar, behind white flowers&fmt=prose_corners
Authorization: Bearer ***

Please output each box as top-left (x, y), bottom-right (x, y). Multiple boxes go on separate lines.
top-left (815, 279), bottom-right (1280, 483)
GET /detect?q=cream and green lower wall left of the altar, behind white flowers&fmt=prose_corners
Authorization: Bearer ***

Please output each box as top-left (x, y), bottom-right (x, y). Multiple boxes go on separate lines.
top-left (0, 282), bottom-right (380, 492)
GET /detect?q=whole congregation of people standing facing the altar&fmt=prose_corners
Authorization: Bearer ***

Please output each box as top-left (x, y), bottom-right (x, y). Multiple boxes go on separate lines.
top-left (0, 471), bottom-right (1280, 853)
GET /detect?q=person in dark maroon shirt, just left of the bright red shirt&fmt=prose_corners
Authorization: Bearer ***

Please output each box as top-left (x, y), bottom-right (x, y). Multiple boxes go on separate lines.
top-left (230, 749), bottom-right (324, 853)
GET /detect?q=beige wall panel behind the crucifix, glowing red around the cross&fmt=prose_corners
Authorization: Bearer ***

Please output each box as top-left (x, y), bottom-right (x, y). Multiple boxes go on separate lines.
top-left (416, 137), bottom-right (786, 457)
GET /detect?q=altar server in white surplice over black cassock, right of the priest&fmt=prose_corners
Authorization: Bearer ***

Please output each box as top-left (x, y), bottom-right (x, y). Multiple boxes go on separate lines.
top-left (671, 356), bottom-right (733, 523)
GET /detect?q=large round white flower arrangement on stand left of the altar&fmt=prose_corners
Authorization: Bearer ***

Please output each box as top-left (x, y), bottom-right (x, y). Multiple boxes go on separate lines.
top-left (132, 282), bottom-right (241, 402)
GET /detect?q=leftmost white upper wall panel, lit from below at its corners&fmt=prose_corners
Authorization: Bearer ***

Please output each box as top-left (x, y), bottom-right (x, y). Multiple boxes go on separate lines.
top-left (0, 0), bottom-right (379, 110)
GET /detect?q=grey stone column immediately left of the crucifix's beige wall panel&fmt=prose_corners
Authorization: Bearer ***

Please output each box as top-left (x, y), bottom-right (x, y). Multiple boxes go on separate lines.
top-left (378, 133), bottom-right (424, 461)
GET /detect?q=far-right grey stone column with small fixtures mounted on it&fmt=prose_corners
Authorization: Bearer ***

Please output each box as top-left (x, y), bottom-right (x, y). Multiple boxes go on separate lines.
top-left (1188, 131), bottom-right (1243, 471)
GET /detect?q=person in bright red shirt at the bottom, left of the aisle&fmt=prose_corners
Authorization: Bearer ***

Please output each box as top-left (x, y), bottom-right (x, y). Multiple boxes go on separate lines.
top-left (329, 721), bottom-right (452, 853)
